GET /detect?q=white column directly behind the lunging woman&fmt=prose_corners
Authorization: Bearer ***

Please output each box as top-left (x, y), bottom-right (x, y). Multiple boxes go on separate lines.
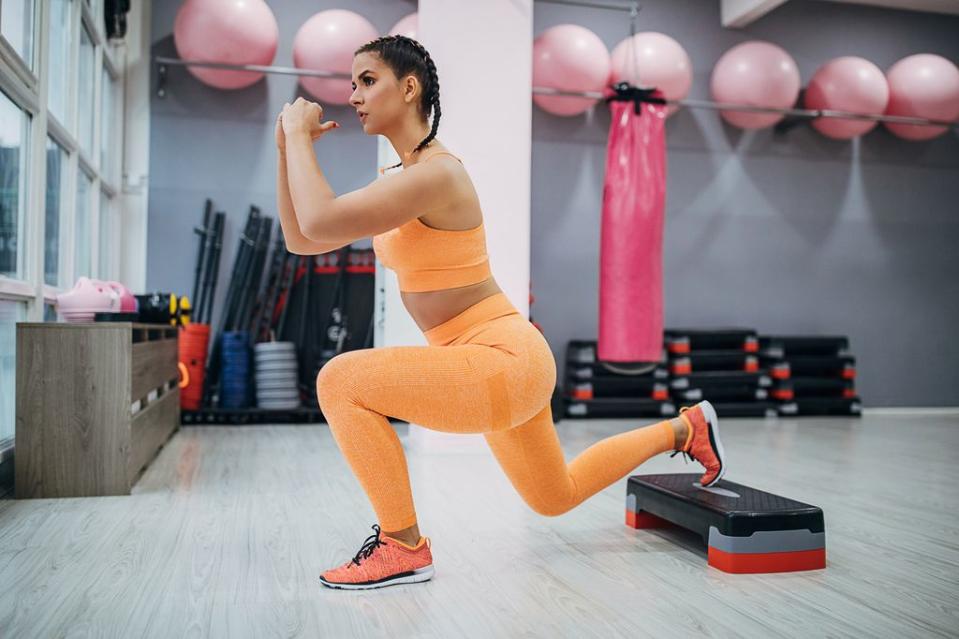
top-left (377, 0), bottom-right (533, 452)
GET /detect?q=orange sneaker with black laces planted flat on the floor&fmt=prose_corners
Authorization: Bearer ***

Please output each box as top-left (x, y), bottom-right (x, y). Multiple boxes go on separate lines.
top-left (320, 524), bottom-right (433, 590)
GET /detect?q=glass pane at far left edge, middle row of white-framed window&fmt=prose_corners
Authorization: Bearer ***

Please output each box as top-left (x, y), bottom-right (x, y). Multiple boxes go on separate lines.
top-left (0, 93), bottom-right (30, 279)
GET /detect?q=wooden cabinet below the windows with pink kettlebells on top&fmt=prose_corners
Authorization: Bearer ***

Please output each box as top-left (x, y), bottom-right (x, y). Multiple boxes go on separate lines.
top-left (14, 322), bottom-right (180, 499)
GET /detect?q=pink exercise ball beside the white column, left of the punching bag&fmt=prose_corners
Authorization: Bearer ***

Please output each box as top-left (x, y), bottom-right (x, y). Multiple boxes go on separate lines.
top-left (533, 24), bottom-right (609, 115)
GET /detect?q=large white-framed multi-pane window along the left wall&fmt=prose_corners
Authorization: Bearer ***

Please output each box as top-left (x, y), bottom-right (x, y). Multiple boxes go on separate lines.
top-left (0, 0), bottom-right (129, 480)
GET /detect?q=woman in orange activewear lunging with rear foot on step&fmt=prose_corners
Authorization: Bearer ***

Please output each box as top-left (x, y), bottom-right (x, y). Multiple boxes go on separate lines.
top-left (276, 36), bottom-right (725, 589)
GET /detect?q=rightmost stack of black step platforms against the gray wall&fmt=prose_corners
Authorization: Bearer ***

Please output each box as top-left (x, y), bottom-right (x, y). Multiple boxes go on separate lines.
top-left (759, 335), bottom-right (862, 416)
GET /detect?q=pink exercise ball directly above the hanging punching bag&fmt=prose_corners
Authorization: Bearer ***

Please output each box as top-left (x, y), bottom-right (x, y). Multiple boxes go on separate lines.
top-left (607, 31), bottom-right (693, 115)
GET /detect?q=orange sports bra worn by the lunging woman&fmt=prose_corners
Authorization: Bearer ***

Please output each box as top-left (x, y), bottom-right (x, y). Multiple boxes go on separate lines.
top-left (373, 151), bottom-right (491, 293)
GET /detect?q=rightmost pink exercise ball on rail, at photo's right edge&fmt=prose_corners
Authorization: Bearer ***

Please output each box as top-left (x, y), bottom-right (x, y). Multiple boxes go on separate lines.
top-left (883, 53), bottom-right (959, 140)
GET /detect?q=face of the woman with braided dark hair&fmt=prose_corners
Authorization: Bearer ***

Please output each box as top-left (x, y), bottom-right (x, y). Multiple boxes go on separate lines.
top-left (350, 52), bottom-right (406, 135)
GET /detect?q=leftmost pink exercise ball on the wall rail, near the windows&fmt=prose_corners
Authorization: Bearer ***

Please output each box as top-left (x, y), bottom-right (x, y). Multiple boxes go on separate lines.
top-left (173, 0), bottom-right (280, 89)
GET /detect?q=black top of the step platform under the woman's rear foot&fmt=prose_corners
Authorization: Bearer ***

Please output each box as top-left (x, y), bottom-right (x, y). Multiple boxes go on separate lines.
top-left (626, 473), bottom-right (825, 538)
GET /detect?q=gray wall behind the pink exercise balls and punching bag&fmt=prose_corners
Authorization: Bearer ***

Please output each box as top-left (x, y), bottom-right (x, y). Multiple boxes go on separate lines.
top-left (147, 0), bottom-right (959, 406)
